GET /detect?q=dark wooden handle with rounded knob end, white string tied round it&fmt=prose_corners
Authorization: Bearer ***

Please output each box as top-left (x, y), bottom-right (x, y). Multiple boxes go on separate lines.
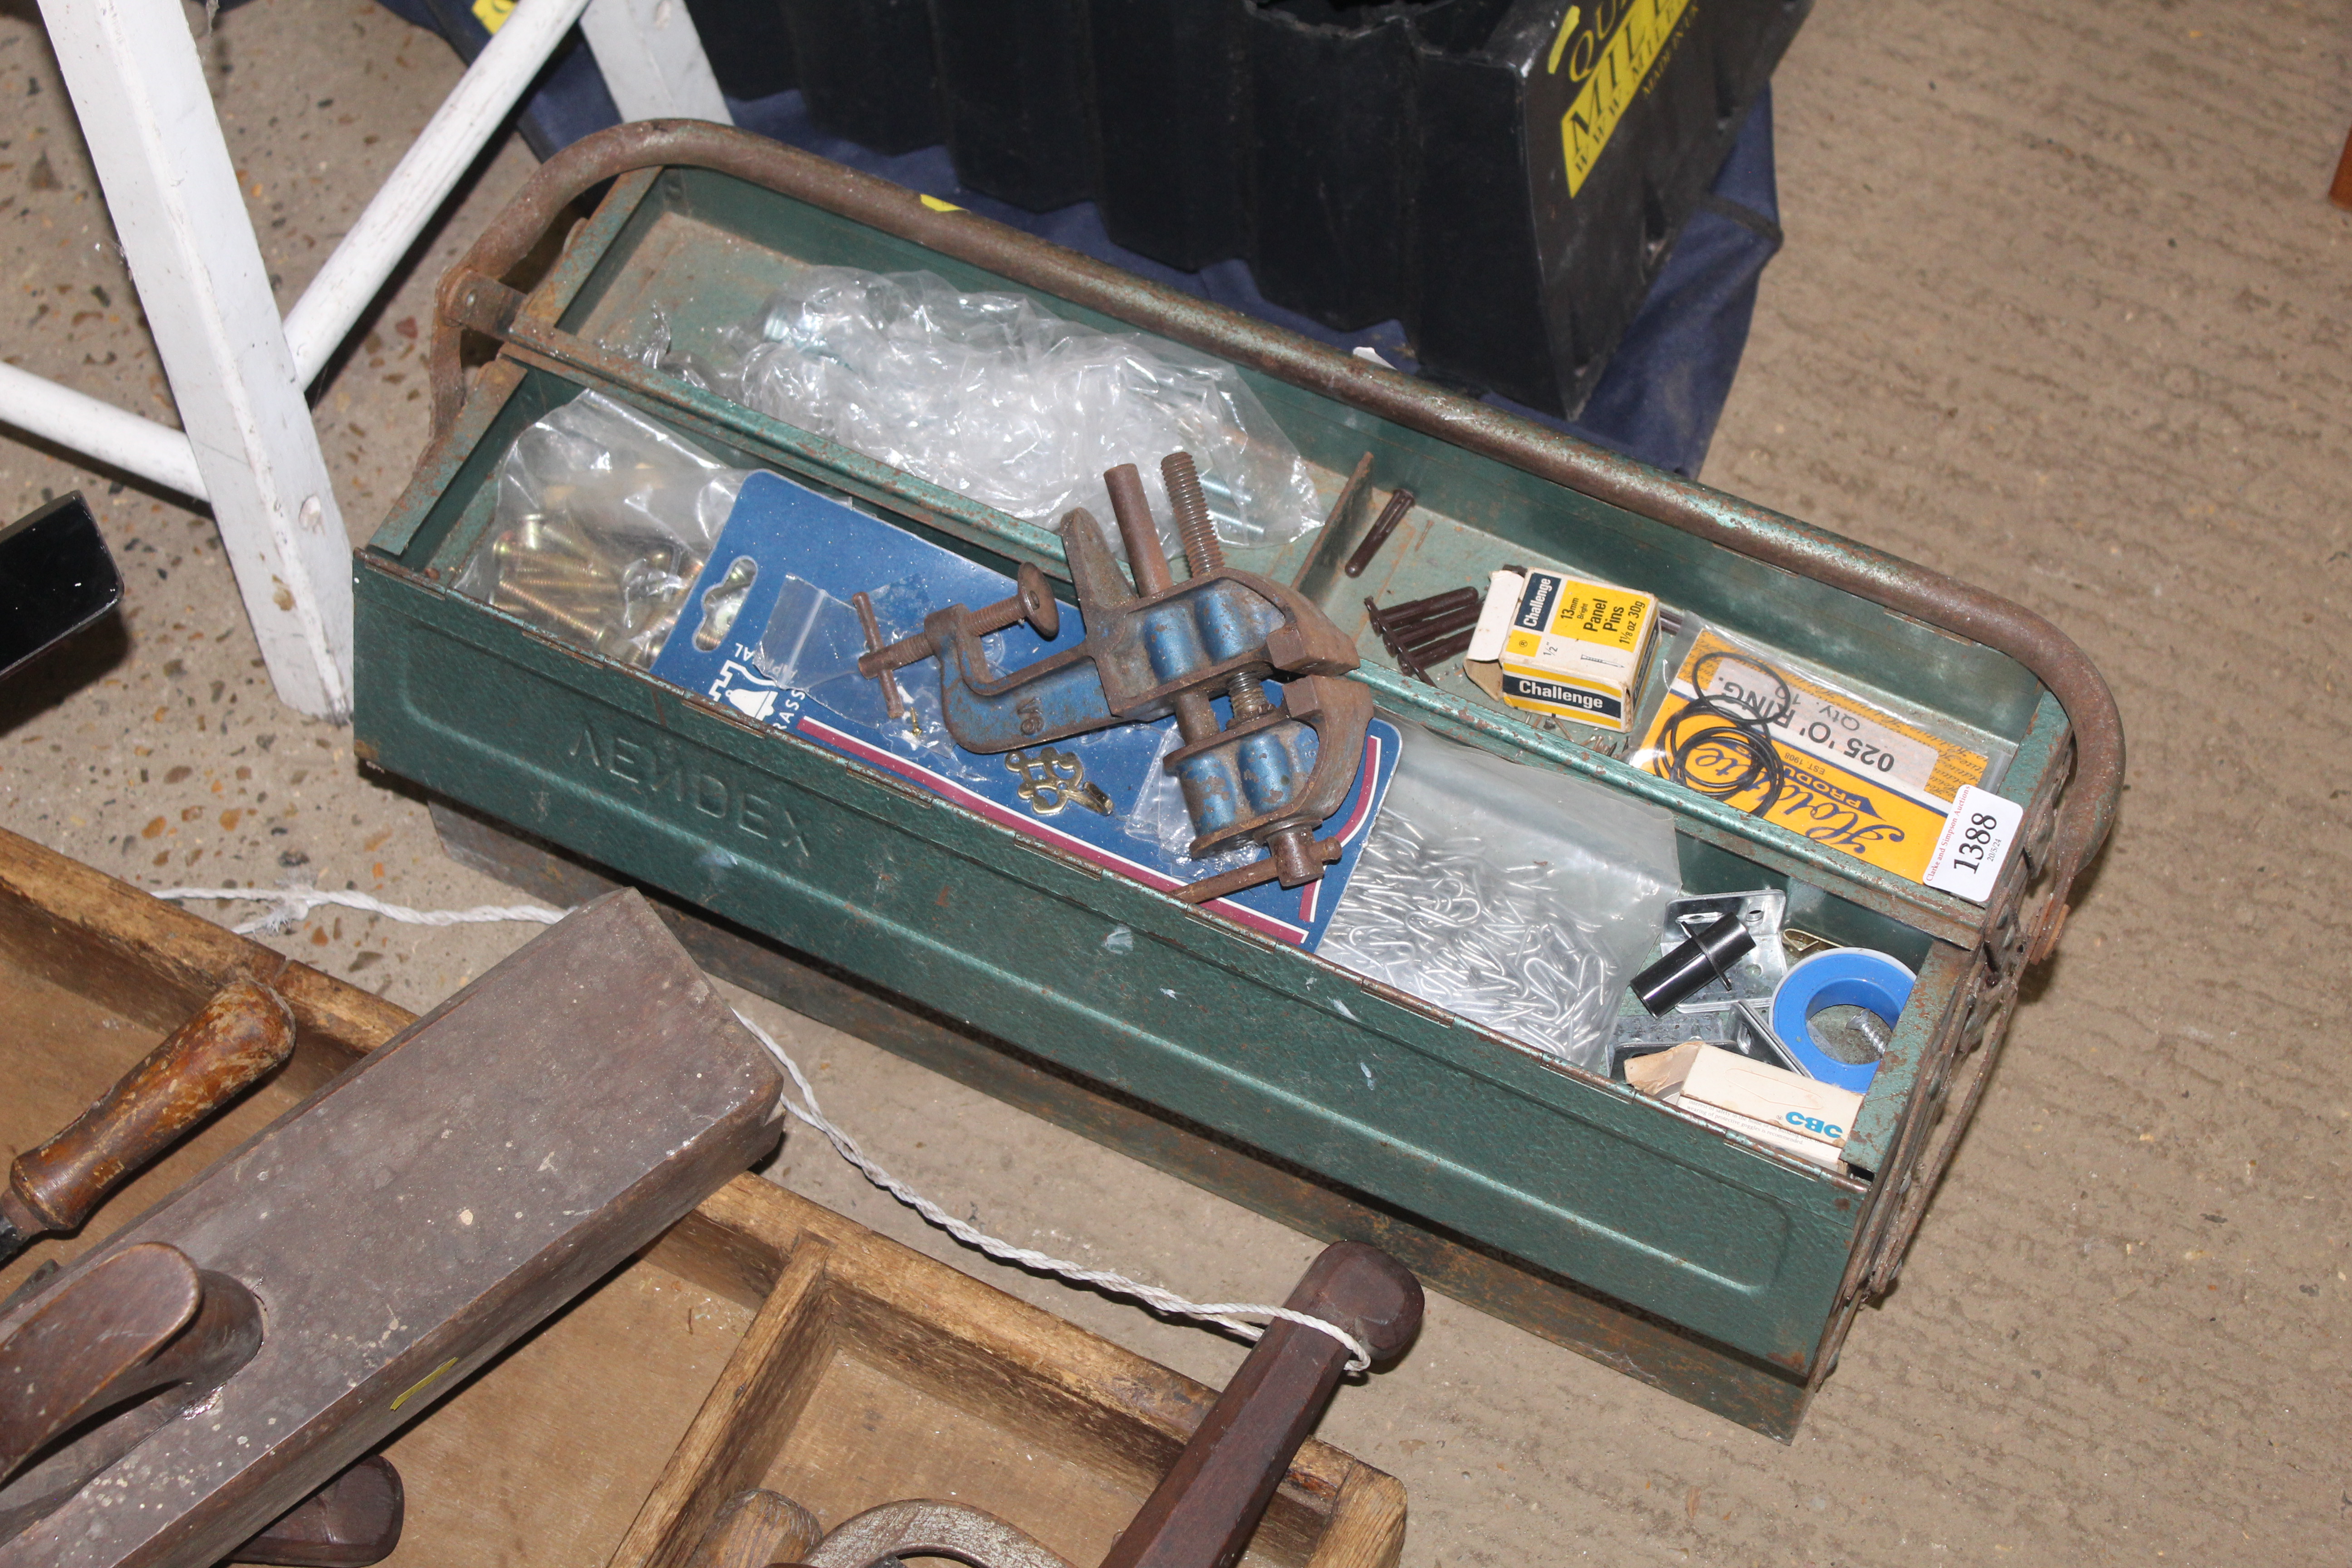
top-left (1103, 1241), bottom-right (1421, 1568)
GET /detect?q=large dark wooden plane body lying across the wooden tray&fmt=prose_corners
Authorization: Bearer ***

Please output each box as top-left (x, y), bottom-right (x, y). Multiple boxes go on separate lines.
top-left (0, 891), bottom-right (783, 1568)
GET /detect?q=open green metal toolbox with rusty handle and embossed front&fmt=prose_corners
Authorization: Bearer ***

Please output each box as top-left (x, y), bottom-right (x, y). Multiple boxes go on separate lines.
top-left (355, 122), bottom-right (2122, 1436)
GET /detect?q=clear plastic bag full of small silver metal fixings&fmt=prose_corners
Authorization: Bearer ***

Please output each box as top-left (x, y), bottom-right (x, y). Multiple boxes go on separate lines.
top-left (1317, 726), bottom-right (1682, 1074)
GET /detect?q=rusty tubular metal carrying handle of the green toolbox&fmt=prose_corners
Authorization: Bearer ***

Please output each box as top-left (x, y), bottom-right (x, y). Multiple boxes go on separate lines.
top-left (428, 120), bottom-right (2124, 964)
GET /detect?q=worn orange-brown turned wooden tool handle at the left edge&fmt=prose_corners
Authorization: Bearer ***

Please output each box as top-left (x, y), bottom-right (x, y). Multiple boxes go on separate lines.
top-left (0, 980), bottom-right (294, 1236)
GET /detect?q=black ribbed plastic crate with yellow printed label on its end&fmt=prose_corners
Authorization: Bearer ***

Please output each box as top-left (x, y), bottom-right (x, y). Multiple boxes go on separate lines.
top-left (785, 0), bottom-right (1811, 414)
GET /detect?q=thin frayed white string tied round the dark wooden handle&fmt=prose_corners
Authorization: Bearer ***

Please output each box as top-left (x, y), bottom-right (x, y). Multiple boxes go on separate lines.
top-left (155, 889), bottom-right (1371, 1373)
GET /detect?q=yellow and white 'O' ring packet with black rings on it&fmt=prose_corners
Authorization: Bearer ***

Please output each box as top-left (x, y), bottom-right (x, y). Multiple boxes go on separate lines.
top-left (1635, 630), bottom-right (1990, 882)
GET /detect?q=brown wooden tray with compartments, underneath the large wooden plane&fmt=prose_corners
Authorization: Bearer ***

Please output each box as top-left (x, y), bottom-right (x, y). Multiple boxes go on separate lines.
top-left (0, 830), bottom-right (1404, 1568)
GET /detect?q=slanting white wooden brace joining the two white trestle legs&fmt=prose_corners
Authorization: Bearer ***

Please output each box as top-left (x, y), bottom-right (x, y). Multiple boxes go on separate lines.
top-left (279, 0), bottom-right (593, 386)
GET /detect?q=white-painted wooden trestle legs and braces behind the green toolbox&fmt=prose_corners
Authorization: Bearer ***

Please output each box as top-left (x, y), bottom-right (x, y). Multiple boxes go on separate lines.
top-left (25, 0), bottom-right (731, 720)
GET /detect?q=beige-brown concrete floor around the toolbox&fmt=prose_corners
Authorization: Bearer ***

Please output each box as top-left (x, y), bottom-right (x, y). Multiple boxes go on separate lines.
top-left (0, 0), bottom-right (2352, 1568)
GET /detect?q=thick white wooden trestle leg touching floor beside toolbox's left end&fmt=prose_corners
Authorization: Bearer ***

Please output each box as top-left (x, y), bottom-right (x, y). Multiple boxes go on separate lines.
top-left (40, 0), bottom-right (353, 720)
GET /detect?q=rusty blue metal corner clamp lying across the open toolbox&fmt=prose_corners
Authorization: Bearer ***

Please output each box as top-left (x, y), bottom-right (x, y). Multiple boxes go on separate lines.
top-left (858, 451), bottom-right (1371, 903)
